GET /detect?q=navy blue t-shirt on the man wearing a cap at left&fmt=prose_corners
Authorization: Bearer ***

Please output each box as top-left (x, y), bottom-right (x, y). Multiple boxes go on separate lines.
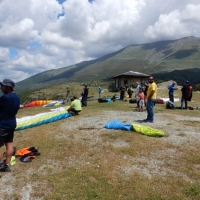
top-left (0, 93), bottom-right (20, 129)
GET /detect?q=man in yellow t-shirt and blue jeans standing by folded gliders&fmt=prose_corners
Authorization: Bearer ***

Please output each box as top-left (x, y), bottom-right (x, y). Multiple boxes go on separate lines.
top-left (144, 76), bottom-right (157, 123)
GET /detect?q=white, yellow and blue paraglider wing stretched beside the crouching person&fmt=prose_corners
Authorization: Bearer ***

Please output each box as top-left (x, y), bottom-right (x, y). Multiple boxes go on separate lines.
top-left (15, 110), bottom-right (72, 131)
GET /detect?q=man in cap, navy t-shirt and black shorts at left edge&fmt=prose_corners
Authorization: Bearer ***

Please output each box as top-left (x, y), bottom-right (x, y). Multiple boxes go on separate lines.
top-left (0, 79), bottom-right (20, 172)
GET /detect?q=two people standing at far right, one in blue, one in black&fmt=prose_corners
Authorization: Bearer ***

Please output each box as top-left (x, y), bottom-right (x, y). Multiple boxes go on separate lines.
top-left (168, 81), bottom-right (192, 109)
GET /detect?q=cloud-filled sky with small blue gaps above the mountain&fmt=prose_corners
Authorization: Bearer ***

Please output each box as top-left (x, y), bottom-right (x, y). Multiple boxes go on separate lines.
top-left (0, 0), bottom-right (200, 82)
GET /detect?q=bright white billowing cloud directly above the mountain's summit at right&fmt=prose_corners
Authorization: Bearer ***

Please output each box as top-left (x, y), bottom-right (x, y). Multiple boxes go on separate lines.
top-left (144, 4), bottom-right (200, 40)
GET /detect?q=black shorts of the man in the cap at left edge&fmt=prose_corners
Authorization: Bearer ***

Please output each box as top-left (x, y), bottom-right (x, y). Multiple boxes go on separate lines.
top-left (0, 128), bottom-right (15, 147)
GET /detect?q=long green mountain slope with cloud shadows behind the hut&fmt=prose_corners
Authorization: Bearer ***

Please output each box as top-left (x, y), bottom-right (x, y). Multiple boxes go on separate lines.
top-left (16, 37), bottom-right (200, 93)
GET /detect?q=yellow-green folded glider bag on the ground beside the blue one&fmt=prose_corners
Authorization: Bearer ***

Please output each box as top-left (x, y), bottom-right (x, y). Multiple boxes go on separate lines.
top-left (132, 124), bottom-right (165, 137)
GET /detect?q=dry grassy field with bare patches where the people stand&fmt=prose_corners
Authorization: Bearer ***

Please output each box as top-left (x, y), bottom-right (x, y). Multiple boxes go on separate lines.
top-left (0, 86), bottom-right (200, 200)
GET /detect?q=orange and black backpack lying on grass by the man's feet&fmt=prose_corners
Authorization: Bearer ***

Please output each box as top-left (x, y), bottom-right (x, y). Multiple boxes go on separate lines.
top-left (15, 147), bottom-right (40, 162)
